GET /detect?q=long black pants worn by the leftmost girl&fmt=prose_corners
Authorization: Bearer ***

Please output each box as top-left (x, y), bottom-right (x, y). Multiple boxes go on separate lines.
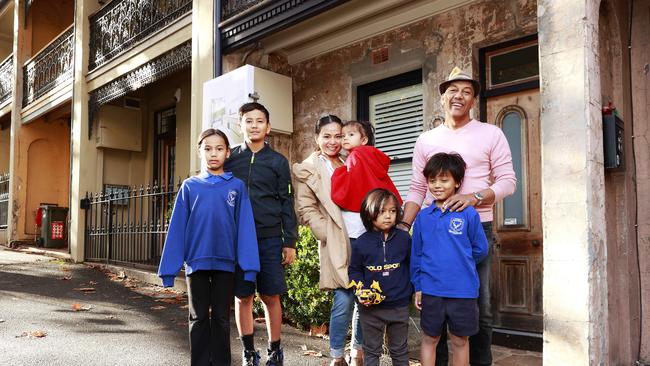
top-left (187, 271), bottom-right (234, 366)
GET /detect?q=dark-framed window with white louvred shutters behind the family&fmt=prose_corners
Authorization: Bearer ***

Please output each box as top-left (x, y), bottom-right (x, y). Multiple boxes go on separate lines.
top-left (357, 70), bottom-right (424, 198)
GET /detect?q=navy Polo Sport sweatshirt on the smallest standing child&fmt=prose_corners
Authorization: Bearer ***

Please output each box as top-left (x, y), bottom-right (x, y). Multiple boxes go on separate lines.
top-left (348, 228), bottom-right (413, 308)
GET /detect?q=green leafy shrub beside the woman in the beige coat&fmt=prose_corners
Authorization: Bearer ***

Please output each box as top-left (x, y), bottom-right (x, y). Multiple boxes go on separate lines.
top-left (282, 226), bottom-right (332, 329)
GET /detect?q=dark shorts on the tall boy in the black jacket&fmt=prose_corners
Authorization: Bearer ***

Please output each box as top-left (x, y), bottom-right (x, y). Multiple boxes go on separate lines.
top-left (234, 237), bottom-right (287, 297)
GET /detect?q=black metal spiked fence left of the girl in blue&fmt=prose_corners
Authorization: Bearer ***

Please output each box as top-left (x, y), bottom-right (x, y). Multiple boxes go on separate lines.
top-left (82, 180), bottom-right (181, 267)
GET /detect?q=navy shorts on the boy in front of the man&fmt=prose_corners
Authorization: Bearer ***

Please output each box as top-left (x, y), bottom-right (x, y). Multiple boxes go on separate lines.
top-left (420, 294), bottom-right (478, 337)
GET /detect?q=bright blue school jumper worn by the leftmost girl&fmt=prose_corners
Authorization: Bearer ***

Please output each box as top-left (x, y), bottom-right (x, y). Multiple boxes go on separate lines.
top-left (158, 172), bottom-right (260, 287)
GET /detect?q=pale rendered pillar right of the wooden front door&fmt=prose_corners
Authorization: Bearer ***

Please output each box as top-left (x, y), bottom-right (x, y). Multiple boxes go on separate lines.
top-left (538, 0), bottom-right (609, 366)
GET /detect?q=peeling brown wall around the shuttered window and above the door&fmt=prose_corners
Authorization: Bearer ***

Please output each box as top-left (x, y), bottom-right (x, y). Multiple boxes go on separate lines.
top-left (292, 0), bottom-right (537, 161)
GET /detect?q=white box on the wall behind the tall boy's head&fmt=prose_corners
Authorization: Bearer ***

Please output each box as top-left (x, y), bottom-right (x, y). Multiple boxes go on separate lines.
top-left (202, 65), bottom-right (293, 145)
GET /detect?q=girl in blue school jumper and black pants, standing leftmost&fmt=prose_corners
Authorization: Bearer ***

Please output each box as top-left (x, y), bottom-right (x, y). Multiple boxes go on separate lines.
top-left (158, 128), bottom-right (260, 366)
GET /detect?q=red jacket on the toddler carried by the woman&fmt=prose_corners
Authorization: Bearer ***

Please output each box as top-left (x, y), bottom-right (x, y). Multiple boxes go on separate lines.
top-left (332, 145), bottom-right (402, 212)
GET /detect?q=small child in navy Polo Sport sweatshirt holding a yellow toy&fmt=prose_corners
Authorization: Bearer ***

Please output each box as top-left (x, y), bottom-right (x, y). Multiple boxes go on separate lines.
top-left (348, 188), bottom-right (413, 366)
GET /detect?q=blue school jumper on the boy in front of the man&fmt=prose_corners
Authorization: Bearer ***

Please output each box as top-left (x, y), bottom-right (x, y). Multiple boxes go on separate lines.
top-left (411, 204), bottom-right (488, 299)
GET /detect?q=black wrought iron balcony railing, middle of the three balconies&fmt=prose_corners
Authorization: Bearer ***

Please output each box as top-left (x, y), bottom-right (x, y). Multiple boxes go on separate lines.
top-left (23, 25), bottom-right (74, 107)
